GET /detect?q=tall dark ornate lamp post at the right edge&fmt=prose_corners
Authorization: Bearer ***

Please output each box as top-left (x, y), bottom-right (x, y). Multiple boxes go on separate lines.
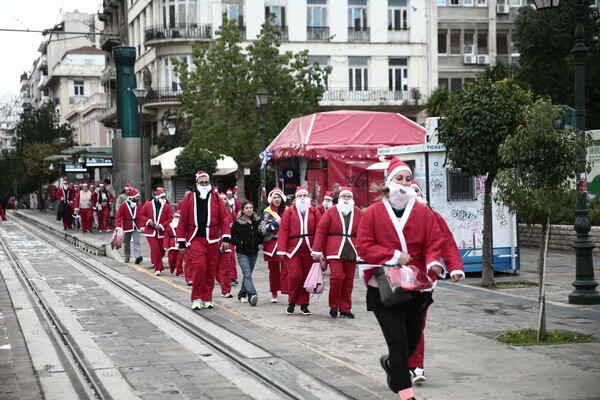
top-left (534, 0), bottom-right (600, 304)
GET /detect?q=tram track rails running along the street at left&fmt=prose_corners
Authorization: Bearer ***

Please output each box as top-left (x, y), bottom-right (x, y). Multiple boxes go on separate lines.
top-left (2, 216), bottom-right (348, 399)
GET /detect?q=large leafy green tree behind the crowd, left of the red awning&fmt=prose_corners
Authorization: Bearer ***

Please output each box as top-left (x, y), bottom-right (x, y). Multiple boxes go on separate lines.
top-left (176, 19), bottom-right (329, 197)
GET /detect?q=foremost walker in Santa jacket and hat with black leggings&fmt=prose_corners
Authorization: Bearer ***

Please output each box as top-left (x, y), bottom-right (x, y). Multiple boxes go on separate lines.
top-left (356, 156), bottom-right (446, 400)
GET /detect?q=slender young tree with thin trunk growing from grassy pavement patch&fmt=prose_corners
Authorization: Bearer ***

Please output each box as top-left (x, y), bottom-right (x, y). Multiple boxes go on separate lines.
top-left (496, 99), bottom-right (591, 341)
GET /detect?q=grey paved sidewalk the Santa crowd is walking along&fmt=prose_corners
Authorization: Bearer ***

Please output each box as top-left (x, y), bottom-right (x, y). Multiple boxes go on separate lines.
top-left (8, 210), bottom-right (600, 400)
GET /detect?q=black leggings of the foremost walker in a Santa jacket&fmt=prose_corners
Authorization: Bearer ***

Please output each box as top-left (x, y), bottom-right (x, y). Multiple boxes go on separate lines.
top-left (374, 292), bottom-right (431, 391)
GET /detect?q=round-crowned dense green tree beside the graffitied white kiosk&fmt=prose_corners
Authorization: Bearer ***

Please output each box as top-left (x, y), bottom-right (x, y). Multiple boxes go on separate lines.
top-left (439, 79), bottom-right (532, 286)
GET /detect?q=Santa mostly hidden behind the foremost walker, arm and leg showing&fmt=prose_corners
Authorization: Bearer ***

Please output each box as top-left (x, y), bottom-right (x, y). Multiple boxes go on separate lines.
top-left (408, 181), bottom-right (465, 383)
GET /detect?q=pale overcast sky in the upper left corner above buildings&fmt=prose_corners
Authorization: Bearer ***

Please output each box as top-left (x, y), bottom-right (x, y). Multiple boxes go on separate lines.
top-left (0, 0), bottom-right (102, 98)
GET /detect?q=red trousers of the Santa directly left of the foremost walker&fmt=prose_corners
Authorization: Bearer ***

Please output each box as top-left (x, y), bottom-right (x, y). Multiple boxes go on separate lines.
top-left (328, 260), bottom-right (356, 312)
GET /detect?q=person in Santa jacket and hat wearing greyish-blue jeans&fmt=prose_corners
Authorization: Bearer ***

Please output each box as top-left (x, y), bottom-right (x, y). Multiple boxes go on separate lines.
top-left (115, 188), bottom-right (143, 264)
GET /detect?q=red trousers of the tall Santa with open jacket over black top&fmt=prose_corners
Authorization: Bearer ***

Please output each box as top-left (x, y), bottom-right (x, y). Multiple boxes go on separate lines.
top-left (185, 237), bottom-right (220, 301)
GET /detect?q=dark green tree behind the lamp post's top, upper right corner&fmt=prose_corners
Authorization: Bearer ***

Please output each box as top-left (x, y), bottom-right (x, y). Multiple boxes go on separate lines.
top-left (515, 5), bottom-right (600, 128)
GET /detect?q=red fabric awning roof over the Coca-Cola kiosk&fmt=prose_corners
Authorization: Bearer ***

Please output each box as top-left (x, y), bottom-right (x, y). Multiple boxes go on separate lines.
top-left (267, 110), bottom-right (426, 160)
